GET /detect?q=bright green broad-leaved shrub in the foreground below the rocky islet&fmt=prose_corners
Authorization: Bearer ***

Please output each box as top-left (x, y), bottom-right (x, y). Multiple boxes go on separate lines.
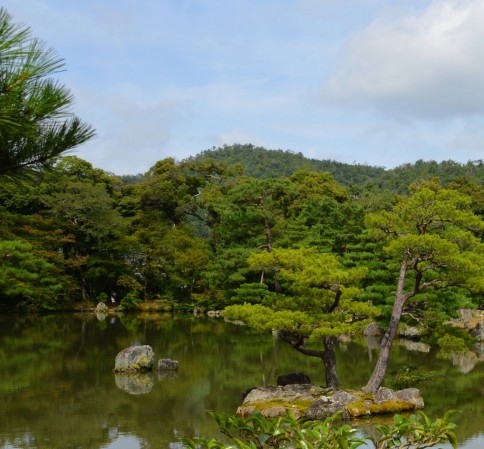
top-left (183, 411), bottom-right (457, 449)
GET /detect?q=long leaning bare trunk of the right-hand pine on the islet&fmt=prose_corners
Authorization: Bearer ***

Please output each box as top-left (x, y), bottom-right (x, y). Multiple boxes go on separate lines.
top-left (363, 258), bottom-right (411, 394)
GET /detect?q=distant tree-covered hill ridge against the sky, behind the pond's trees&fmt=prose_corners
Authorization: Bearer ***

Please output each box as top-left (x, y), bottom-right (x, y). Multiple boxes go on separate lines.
top-left (188, 144), bottom-right (484, 193)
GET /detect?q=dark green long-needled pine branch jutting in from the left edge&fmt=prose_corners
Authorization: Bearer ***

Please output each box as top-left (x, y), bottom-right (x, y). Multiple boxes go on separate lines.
top-left (0, 8), bottom-right (94, 179)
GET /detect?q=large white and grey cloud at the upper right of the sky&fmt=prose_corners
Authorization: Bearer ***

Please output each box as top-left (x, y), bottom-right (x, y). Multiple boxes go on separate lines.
top-left (325, 0), bottom-right (484, 118)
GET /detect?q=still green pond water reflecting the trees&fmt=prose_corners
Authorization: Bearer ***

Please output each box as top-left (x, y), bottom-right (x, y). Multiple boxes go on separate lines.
top-left (0, 315), bottom-right (484, 449)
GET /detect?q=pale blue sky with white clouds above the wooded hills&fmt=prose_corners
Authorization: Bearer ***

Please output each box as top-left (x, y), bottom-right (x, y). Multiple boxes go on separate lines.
top-left (1, 0), bottom-right (484, 175)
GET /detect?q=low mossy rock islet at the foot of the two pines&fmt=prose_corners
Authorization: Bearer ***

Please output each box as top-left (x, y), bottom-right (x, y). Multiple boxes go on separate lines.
top-left (237, 384), bottom-right (424, 419)
